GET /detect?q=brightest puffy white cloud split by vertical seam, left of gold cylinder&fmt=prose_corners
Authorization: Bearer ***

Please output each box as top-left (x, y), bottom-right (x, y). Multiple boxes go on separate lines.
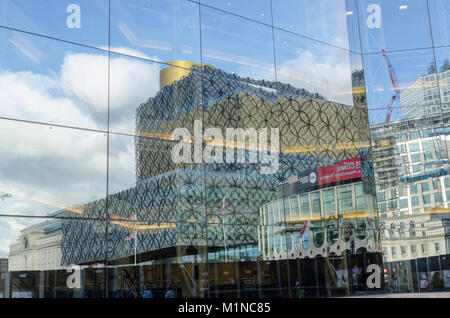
top-left (57, 48), bottom-right (160, 133)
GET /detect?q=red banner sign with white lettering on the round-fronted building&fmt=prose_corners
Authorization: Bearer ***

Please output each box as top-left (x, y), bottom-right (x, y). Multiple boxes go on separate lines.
top-left (317, 158), bottom-right (361, 185)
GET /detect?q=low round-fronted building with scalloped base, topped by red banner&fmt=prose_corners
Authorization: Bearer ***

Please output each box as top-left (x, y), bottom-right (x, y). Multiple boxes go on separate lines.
top-left (260, 159), bottom-right (379, 260)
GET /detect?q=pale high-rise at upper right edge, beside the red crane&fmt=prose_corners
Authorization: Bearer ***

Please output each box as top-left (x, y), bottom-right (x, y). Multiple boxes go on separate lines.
top-left (400, 69), bottom-right (450, 118)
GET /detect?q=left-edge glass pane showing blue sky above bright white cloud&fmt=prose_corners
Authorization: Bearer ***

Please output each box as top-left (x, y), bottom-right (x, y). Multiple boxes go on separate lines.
top-left (0, 29), bottom-right (108, 130)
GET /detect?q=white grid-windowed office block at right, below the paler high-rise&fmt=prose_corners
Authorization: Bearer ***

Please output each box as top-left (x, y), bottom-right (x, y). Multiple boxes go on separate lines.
top-left (372, 112), bottom-right (450, 217)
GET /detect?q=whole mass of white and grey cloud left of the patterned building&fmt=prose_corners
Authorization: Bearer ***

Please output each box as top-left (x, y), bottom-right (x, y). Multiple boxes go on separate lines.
top-left (0, 48), bottom-right (160, 255)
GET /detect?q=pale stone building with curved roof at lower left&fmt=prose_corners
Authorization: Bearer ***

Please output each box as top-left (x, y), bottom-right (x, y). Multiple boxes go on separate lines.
top-left (8, 220), bottom-right (64, 271)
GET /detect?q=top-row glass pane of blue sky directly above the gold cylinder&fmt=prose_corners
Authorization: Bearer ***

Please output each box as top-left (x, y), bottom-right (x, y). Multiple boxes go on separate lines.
top-left (111, 0), bottom-right (200, 63)
